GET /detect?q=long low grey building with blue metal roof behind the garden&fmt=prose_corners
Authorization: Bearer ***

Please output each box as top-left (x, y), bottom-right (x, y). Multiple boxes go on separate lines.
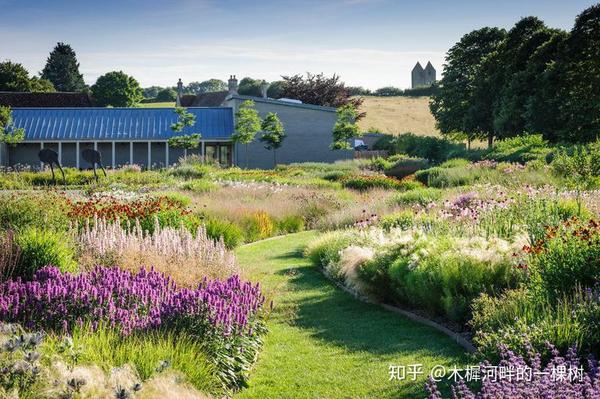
top-left (0, 76), bottom-right (353, 169)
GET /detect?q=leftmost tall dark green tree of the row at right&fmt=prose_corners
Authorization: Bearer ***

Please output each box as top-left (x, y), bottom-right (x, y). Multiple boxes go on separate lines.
top-left (429, 27), bottom-right (506, 145)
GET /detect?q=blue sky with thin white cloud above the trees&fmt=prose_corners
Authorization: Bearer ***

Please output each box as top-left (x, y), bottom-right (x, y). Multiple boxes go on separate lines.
top-left (0, 0), bottom-right (598, 89)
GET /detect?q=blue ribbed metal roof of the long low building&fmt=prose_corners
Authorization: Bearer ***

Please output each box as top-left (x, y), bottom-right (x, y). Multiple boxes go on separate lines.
top-left (12, 107), bottom-right (234, 141)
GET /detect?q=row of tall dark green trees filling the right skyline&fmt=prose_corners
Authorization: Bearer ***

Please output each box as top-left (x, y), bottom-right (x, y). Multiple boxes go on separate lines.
top-left (430, 4), bottom-right (600, 147)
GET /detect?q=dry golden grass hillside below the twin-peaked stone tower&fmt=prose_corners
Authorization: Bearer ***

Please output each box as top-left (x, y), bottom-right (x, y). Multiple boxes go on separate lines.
top-left (359, 96), bottom-right (439, 136)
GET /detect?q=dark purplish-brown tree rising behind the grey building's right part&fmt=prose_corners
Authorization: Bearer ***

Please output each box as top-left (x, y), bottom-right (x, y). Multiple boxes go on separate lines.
top-left (281, 73), bottom-right (365, 119)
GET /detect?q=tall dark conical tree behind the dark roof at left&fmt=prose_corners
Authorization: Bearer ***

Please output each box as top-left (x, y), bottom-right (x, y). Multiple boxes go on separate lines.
top-left (42, 43), bottom-right (85, 91)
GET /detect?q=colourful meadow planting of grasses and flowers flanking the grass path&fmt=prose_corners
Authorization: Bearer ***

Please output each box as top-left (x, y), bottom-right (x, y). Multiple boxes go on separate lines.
top-left (0, 135), bottom-right (600, 398)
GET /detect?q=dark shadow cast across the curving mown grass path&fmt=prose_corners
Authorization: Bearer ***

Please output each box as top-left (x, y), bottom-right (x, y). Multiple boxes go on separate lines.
top-left (277, 260), bottom-right (463, 357)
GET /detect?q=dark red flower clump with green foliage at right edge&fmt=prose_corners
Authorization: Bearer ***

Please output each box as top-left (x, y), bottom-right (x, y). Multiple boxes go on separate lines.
top-left (527, 219), bottom-right (600, 298)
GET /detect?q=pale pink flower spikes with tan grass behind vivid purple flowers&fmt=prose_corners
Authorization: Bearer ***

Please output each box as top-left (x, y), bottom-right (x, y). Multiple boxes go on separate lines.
top-left (75, 218), bottom-right (237, 285)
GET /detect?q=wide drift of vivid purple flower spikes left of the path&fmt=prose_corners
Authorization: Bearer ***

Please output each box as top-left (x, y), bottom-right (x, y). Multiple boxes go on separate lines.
top-left (0, 267), bottom-right (265, 335)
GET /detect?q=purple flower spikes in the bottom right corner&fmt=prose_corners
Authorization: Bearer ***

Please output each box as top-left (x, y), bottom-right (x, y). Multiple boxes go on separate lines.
top-left (426, 346), bottom-right (600, 399)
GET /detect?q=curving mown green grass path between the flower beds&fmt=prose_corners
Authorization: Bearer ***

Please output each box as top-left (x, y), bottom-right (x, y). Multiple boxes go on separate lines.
top-left (236, 232), bottom-right (467, 399)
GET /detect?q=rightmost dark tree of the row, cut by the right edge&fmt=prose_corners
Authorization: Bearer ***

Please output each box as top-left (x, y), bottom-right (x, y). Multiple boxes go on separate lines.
top-left (558, 4), bottom-right (600, 142)
